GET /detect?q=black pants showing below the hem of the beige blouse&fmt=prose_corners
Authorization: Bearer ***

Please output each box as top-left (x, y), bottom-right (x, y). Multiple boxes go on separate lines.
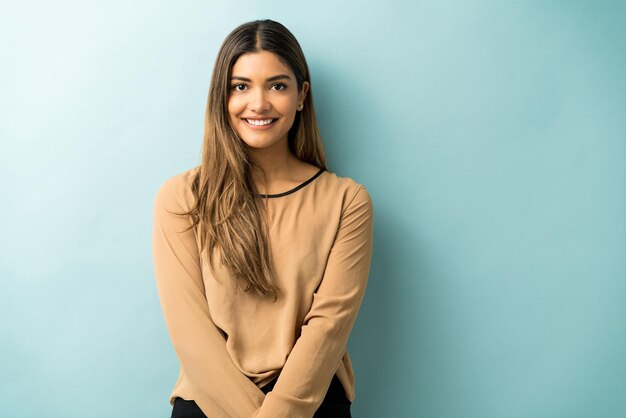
top-left (171, 375), bottom-right (352, 418)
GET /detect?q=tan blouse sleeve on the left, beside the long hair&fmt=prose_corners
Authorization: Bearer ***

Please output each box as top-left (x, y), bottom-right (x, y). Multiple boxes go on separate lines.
top-left (153, 179), bottom-right (264, 418)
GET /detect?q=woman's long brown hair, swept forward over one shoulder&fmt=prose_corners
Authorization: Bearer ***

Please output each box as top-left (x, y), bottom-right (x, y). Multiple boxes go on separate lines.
top-left (174, 20), bottom-right (326, 301)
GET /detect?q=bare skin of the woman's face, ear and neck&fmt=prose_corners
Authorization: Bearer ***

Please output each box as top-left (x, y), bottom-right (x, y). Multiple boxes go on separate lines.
top-left (228, 51), bottom-right (319, 194)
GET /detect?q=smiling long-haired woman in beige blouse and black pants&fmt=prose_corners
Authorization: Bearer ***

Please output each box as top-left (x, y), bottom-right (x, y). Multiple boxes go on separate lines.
top-left (153, 20), bottom-right (373, 418)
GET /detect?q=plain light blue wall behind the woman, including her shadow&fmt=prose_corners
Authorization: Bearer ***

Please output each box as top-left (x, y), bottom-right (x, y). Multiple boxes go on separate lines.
top-left (0, 0), bottom-right (626, 418)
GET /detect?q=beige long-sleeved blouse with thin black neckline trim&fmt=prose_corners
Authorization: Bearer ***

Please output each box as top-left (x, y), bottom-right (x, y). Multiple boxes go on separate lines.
top-left (152, 166), bottom-right (373, 418)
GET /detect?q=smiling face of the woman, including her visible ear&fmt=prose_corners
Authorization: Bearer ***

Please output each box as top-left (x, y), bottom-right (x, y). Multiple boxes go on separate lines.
top-left (228, 51), bottom-right (309, 153)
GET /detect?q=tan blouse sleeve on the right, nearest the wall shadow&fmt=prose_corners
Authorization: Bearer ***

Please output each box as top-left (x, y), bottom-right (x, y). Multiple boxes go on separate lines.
top-left (252, 185), bottom-right (373, 418)
